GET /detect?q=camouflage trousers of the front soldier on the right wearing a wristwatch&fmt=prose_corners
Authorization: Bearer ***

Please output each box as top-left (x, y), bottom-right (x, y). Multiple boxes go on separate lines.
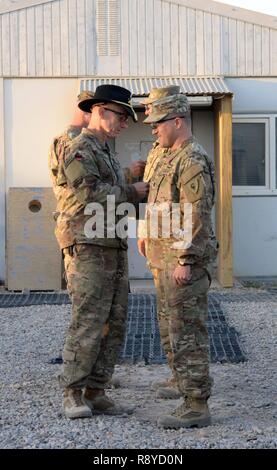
top-left (149, 259), bottom-right (211, 398)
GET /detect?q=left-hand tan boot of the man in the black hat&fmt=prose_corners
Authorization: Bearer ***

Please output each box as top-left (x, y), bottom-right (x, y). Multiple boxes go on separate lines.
top-left (63, 388), bottom-right (92, 419)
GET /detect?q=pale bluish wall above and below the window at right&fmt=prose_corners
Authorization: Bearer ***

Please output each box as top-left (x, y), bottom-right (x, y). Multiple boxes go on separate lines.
top-left (226, 78), bottom-right (277, 276)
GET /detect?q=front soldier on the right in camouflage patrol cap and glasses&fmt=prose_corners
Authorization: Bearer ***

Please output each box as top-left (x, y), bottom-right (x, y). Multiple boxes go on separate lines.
top-left (144, 94), bottom-right (216, 428)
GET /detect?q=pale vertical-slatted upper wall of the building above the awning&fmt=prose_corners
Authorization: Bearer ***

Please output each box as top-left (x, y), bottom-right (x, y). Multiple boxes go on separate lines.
top-left (0, 0), bottom-right (277, 77)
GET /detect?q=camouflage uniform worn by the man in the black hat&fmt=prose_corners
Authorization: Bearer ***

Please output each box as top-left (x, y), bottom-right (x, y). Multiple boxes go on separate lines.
top-left (50, 129), bottom-right (138, 389)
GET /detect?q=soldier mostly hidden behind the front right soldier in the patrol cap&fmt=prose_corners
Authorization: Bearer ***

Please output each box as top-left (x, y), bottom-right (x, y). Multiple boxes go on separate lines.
top-left (138, 85), bottom-right (181, 399)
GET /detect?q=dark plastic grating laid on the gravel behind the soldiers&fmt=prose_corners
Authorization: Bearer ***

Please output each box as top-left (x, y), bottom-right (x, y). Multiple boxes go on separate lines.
top-left (0, 289), bottom-right (254, 364)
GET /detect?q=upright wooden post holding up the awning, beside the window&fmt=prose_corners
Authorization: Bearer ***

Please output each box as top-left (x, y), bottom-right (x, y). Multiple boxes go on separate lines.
top-left (215, 95), bottom-right (233, 287)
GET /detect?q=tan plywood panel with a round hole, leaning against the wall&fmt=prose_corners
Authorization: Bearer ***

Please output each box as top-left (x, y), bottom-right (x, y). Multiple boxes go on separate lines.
top-left (7, 188), bottom-right (61, 290)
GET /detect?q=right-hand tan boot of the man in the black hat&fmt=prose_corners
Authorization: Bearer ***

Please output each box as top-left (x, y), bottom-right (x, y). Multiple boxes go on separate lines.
top-left (83, 387), bottom-right (134, 415)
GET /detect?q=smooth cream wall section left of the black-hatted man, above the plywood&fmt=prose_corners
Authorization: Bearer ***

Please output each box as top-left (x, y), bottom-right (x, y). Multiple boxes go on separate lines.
top-left (0, 79), bottom-right (79, 280)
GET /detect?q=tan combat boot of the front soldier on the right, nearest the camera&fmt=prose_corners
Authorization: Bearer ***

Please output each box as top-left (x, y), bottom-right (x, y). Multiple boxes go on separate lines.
top-left (158, 398), bottom-right (211, 429)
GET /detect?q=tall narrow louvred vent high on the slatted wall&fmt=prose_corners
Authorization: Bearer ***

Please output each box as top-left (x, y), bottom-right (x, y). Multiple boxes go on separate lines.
top-left (96, 0), bottom-right (120, 56)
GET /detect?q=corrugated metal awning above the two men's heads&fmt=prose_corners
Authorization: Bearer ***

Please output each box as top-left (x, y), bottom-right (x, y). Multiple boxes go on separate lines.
top-left (80, 77), bottom-right (232, 97)
